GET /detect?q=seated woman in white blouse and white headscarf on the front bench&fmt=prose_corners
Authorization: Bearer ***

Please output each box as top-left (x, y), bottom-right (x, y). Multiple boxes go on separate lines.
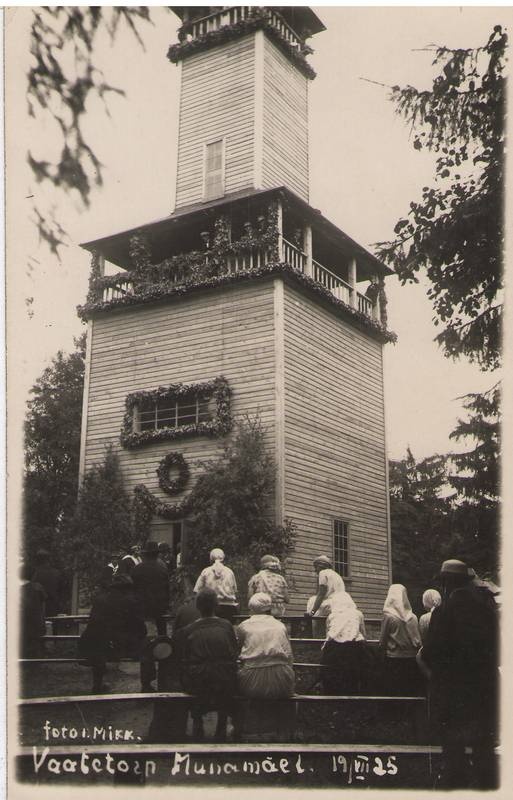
top-left (236, 592), bottom-right (295, 699)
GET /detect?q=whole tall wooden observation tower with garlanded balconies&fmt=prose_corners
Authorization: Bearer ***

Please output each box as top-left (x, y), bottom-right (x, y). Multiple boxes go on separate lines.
top-left (81, 6), bottom-right (393, 615)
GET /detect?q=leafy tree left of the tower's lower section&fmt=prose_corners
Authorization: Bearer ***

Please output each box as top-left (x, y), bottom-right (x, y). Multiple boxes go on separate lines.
top-left (23, 334), bottom-right (85, 560)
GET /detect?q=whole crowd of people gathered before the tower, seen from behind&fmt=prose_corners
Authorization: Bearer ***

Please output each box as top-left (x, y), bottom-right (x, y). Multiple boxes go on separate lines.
top-left (20, 541), bottom-right (498, 788)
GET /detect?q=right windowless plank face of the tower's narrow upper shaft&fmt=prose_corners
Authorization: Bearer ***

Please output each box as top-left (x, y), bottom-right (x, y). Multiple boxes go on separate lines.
top-left (263, 37), bottom-right (308, 201)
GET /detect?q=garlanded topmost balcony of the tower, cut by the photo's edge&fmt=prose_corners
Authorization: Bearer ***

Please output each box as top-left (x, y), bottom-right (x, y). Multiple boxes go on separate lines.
top-left (168, 6), bottom-right (326, 79)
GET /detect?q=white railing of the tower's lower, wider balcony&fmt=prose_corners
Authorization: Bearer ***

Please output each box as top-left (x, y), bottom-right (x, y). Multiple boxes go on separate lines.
top-left (102, 239), bottom-right (376, 319)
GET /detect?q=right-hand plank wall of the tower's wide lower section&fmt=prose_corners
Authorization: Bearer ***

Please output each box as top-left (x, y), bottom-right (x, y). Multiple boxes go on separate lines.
top-left (284, 286), bottom-right (388, 616)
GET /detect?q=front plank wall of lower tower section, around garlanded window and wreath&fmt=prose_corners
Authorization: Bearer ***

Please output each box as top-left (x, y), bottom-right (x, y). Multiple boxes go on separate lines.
top-left (85, 282), bottom-right (274, 544)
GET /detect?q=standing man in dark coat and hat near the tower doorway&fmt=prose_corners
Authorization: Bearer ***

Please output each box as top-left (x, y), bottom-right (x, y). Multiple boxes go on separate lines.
top-left (132, 542), bottom-right (169, 636)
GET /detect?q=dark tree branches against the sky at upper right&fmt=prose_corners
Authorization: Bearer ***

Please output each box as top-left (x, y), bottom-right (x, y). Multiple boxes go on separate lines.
top-left (378, 25), bottom-right (507, 369)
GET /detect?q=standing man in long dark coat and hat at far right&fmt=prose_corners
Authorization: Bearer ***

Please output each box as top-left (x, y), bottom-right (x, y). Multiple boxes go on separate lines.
top-left (420, 559), bottom-right (498, 789)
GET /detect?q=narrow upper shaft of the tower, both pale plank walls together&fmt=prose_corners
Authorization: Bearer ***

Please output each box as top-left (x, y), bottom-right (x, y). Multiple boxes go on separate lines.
top-left (175, 31), bottom-right (308, 208)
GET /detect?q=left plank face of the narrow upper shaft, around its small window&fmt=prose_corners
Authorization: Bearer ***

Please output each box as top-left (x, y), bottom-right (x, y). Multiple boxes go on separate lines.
top-left (176, 34), bottom-right (255, 208)
